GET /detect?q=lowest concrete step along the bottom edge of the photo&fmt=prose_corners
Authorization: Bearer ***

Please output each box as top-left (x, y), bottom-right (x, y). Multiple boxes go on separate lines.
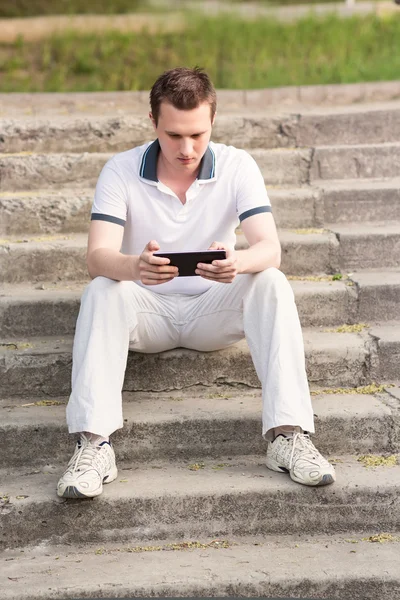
top-left (0, 527), bottom-right (400, 600)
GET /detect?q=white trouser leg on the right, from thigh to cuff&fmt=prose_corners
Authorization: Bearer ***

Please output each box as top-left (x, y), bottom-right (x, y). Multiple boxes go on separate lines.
top-left (181, 268), bottom-right (314, 439)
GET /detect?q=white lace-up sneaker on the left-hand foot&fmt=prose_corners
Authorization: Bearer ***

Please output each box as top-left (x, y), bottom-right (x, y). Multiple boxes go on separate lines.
top-left (57, 433), bottom-right (118, 498)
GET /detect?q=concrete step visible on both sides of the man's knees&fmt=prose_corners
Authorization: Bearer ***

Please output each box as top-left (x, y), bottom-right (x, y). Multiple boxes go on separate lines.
top-left (0, 270), bottom-right (400, 338)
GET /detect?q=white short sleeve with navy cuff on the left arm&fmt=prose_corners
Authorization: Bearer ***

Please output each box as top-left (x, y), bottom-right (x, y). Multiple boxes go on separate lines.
top-left (91, 159), bottom-right (128, 226)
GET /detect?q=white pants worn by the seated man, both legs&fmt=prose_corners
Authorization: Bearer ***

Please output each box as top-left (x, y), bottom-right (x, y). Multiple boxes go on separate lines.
top-left (67, 268), bottom-right (314, 439)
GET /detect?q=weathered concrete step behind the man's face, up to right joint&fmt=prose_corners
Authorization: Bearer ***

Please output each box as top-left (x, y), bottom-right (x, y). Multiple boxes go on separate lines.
top-left (0, 111), bottom-right (298, 153)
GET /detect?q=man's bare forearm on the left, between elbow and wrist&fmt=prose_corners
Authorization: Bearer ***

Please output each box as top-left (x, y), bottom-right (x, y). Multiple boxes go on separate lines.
top-left (87, 248), bottom-right (140, 281)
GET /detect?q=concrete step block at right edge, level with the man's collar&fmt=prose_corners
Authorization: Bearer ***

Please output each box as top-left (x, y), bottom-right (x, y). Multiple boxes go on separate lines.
top-left (311, 144), bottom-right (400, 182)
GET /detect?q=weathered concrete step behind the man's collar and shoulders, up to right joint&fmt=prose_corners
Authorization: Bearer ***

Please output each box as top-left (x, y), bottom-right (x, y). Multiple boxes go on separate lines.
top-left (0, 148), bottom-right (311, 192)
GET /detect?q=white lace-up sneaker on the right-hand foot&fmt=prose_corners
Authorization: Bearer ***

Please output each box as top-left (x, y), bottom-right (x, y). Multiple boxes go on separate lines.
top-left (267, 433), bottom-right (336, 485)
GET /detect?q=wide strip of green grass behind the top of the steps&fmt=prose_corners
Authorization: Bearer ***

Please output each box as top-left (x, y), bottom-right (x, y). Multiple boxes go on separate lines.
top-left (0, 16), bottom-right (400, 92)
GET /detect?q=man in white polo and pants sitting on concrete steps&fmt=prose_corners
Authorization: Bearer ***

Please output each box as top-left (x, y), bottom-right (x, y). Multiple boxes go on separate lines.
top-left (57, 68), bottom-right (335, 498)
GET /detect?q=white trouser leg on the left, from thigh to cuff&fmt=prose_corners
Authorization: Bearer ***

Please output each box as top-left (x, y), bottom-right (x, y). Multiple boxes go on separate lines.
top-left (67, 277), bottom-right (178, 437)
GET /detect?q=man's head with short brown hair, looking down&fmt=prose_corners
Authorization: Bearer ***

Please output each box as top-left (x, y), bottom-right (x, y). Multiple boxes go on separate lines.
top-left (150, 68), bottom-right (216, 176)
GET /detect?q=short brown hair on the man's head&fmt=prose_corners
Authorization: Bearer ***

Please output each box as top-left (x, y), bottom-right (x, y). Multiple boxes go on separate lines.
top-left (150, 67), bottom-right (217, 125)
